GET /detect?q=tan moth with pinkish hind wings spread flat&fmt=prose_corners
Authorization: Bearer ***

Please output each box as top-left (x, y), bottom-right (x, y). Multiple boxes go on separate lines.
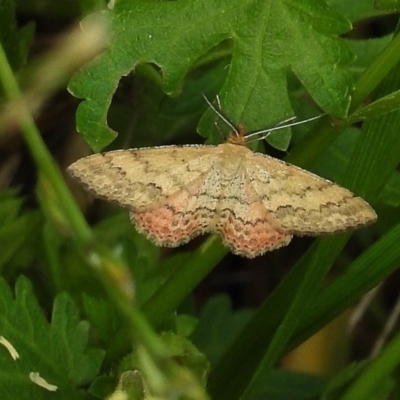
top-left (69, 106), bottom-right (377, 258)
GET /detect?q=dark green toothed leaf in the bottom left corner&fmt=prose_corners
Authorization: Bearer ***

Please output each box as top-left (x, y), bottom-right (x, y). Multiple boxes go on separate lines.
top-left (0, 277), bottom-right (103, 400)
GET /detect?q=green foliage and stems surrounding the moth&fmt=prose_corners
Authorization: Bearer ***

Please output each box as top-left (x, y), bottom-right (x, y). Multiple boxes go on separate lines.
top-left (0, 0), bottom-right (400, 399)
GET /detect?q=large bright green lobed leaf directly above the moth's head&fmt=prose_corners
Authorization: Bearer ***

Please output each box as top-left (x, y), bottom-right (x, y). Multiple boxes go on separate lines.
top-left (70, 0), bottom-right (353, 151)
